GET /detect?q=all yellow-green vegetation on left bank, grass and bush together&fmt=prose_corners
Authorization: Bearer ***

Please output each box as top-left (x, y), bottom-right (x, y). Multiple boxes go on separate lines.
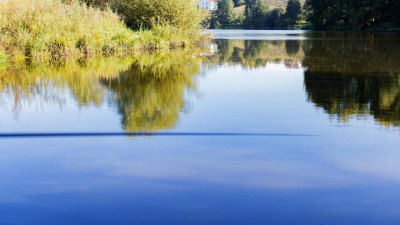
top-left (0, 0), bottom-right (208, 64)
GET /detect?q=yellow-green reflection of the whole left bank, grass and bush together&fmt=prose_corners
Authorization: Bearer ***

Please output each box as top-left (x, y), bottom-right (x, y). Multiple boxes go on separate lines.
top-left (0, 51), bottom-right (200, 131)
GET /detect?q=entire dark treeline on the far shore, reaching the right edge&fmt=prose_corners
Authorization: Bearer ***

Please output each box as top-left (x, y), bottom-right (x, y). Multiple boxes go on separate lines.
top-left (209, 0), bottom-right (400, 30)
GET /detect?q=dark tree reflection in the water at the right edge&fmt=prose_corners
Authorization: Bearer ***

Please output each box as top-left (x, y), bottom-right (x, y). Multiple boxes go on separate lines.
top-left (303, 33), bottom-right (400, 126)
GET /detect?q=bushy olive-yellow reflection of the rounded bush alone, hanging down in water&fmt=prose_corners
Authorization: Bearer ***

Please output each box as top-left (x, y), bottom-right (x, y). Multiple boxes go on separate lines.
top-left (101, 55), bottom-right (199, 131)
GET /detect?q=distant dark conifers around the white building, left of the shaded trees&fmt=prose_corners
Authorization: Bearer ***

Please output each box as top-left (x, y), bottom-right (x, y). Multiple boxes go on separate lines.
top-left (209, 0), bottom-right (303, 28)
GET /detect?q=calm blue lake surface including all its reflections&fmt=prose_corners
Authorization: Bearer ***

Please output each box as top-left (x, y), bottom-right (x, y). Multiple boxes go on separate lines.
top-left (0, 30), bottom-right (400, 225)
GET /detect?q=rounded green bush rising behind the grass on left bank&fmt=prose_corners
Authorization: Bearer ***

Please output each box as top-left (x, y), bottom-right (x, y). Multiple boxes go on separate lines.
top-left (83, 0), bottom-right (207, 45)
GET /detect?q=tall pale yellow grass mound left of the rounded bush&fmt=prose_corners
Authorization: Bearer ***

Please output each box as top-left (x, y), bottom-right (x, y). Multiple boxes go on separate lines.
top-left (0, 0), bottom-right (137, 60)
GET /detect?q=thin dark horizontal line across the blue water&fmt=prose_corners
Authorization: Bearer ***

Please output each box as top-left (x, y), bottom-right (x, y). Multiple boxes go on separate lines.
top-left (0, 132), bottom-right (324, 138)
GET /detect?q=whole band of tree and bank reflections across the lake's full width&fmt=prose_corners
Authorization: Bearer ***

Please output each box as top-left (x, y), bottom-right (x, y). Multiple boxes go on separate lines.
top-left (0, 32), bottom-right (400, 131)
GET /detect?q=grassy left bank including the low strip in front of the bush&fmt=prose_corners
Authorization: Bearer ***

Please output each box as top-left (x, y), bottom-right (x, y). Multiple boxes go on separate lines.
top-left (0, 0), bottom-right (208, 64)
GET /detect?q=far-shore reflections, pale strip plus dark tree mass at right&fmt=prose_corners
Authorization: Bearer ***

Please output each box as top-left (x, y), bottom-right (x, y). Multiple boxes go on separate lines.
top-left (208, 32), bottom-right (400, 126)
